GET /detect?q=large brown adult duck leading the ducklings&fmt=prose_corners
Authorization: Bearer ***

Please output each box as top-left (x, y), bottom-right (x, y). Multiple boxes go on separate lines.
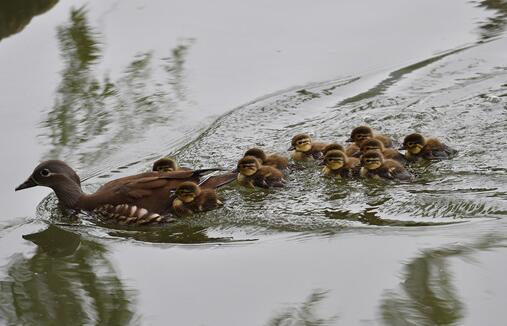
top-left (15, 160), bottom-right (237, 225)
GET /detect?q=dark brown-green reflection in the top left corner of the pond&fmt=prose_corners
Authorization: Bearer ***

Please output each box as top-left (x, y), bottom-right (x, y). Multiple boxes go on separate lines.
top-left (0, 0), bottom-right (58, 40)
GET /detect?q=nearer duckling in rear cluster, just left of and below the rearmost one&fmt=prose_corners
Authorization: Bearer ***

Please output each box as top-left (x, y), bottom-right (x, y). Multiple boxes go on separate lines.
top-left (360, 151), bottom-right (413, 180)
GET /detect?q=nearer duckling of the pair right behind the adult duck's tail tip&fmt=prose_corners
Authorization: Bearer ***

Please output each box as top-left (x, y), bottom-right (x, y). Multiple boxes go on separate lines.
top-left (238, 156), bottom-right (285, 188)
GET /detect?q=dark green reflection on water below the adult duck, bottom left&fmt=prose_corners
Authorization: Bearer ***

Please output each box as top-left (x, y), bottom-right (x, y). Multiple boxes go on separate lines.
top-left (0, 226), bottom-right (138, 325)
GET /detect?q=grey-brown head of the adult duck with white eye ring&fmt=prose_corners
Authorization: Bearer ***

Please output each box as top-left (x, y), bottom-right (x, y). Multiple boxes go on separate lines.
top-left (15, 160), bottom-right (81, 191)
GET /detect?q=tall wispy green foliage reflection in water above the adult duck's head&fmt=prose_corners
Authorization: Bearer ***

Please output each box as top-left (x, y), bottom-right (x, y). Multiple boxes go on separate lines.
top-left (42, 7), bottom-right (192, 163)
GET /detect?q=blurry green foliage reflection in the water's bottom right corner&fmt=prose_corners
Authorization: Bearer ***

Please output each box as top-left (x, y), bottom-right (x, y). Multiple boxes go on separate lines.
top-left (381, 236), bottom-right (506, 326)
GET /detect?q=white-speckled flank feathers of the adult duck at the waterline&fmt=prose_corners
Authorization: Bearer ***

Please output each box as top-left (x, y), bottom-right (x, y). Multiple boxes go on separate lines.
top-left (93, 204), bottom-right (172, 225)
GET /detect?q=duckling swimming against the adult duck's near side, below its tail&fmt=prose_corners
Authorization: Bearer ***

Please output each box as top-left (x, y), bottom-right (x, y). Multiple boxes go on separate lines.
top-left (172, 181), bottom-right (223, 216)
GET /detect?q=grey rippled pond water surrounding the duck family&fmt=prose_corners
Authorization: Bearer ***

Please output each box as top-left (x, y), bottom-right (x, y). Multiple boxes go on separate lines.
top-left (0, 0), bottom-right (507, 325)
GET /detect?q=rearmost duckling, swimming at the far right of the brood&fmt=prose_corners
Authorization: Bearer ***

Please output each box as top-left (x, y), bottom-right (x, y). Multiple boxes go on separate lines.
top-left (400, 133), bottom-right (458, 161)
